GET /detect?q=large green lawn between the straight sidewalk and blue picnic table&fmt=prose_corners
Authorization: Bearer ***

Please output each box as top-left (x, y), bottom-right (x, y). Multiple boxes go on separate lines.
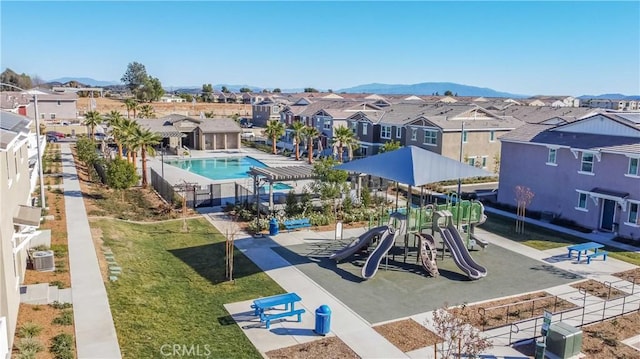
top-left (91, 219), bottom-right (283, 358)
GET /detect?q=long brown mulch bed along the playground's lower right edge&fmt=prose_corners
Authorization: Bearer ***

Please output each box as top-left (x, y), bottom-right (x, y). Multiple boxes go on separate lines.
top-left (449, 292), bottom-right (576, 331)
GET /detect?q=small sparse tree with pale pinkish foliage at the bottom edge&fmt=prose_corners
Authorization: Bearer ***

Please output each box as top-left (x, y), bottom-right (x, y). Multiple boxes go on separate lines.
top-left (433, 304), bottom-right (492, 358)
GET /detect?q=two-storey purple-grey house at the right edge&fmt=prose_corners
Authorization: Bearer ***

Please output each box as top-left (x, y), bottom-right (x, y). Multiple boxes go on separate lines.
top-left (498, 112), bottom-right (640, 239)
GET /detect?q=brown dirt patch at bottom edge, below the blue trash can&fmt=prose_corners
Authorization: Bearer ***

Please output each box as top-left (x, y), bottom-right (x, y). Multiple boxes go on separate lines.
top-left (266, 337), bottom-right (360, 359)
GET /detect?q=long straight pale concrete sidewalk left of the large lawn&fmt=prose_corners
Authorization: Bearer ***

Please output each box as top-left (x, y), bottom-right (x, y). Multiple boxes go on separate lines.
top-left (61, 144), bottom-right (121, 359)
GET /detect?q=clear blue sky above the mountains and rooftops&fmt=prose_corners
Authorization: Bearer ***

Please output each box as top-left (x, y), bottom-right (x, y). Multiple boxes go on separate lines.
top-left (0, 0), bottom-right (640, 95)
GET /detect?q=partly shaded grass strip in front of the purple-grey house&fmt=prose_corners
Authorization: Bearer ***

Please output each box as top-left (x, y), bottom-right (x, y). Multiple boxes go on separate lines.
top-left (480, 214), bottom-right (640, 266)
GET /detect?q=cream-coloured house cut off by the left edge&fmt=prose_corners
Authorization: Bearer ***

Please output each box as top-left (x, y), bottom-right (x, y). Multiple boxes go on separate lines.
top-left (0, 111), bottom-right (44, 358)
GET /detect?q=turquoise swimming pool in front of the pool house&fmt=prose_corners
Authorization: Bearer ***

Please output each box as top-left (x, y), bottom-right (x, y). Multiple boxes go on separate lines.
top-left (165, 156), bottom-right (267, 180)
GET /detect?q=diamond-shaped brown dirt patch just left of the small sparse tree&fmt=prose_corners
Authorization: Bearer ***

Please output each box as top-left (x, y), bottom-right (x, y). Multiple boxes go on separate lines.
top-left (373, 319), bottom-right (443, 353)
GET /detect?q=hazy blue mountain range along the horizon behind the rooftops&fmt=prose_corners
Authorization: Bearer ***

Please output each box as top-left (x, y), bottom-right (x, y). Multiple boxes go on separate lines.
top-left (49, 77), bottom-right (640, 100)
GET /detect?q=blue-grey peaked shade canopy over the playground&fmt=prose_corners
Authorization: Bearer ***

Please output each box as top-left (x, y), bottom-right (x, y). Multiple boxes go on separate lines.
top-left (335, 146), bottom-right (494, 186)
